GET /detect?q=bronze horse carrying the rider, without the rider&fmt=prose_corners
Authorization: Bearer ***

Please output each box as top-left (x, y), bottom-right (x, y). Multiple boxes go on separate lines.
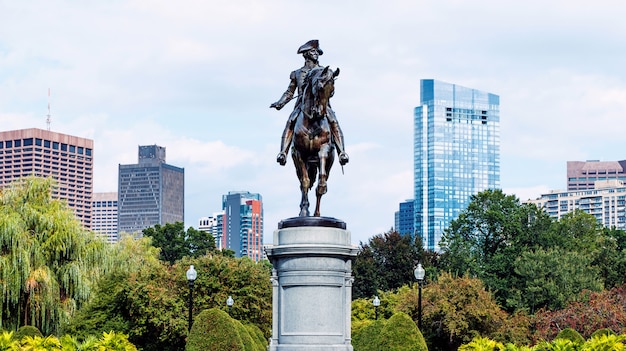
top-left (291, 66), bottom-right (339, 217)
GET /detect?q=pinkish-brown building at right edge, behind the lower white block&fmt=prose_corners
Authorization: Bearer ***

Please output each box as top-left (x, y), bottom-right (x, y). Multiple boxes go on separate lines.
top-left (567, 160), bottom-right (626, 191)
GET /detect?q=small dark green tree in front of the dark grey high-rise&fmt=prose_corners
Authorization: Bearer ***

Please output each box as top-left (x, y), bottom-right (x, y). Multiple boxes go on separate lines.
top-left (143, 222), bottom-right (215, 264)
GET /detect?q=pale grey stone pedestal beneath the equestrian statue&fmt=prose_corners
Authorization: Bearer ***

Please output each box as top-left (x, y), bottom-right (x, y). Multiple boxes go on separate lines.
top-left (267, 217), bottom-right (357, 351)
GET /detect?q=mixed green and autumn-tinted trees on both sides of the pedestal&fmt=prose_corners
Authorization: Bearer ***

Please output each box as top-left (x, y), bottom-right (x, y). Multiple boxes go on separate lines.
top-left (0, 177), bottom-right (626, 351)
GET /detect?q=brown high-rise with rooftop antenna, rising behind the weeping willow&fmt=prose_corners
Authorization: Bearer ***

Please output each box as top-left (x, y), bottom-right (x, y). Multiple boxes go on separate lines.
top-left (0, 128), bottom-right (93, 229)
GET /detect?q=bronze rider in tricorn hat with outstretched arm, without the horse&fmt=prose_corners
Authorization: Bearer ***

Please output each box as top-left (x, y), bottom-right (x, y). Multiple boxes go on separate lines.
top-left (270, 40), bottom-right (349, 166)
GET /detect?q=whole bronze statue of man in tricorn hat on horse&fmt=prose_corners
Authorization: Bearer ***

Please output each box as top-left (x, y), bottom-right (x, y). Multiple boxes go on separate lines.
top-left (270, 40), bottom-right (349, 217)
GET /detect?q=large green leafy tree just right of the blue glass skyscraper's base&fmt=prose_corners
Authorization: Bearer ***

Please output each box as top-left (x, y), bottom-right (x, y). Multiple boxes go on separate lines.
top-left (442, 190), bottom-right (604, 312)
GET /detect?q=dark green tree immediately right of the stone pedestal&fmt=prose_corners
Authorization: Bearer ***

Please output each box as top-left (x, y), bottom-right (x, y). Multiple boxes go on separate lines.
top-left (352, 231), bottom-right (423, 298)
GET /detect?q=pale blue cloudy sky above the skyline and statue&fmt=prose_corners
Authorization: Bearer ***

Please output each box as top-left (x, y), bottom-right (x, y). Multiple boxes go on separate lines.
top-left (0, 0), bottom-right (626, 248)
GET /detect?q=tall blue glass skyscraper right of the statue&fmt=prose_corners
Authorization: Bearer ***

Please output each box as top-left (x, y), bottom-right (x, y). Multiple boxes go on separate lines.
top-left (414, 79), bottom-right (500, 251)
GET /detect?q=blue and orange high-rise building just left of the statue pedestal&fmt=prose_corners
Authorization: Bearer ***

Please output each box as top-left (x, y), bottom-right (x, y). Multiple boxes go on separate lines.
top-left (221, 191), bottom-right (264, 261)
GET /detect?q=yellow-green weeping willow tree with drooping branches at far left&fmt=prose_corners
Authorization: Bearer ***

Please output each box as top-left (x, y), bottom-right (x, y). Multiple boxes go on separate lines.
top-left (0, 177), bottom-right (110, 335)
